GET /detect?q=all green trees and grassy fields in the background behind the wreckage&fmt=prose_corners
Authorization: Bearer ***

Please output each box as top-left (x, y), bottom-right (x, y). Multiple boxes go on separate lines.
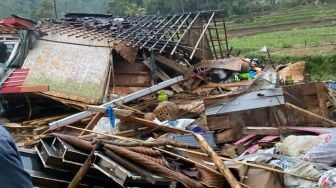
top-left (0, 0), bottom-right (336, 80)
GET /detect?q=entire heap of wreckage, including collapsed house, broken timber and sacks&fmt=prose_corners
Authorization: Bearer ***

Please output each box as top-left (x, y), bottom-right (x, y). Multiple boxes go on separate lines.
top-left (0, 11), bottom-right (336, 188)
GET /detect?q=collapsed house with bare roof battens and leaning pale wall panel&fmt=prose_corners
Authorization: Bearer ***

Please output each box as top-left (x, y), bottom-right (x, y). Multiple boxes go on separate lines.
top-left (23, 12), bottom-right (227, 104)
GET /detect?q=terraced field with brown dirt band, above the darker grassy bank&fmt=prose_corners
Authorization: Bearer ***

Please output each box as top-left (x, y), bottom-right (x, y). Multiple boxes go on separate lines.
top-left (226, 3), bottom-right (336, 55)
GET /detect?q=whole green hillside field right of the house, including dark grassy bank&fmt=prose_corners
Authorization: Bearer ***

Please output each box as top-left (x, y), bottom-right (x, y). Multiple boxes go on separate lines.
top-left (226, 4), bottom-right (336, 81)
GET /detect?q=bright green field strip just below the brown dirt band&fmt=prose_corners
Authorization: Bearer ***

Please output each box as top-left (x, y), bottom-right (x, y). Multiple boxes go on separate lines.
top-left (229, 26), bottom-right (336, 53)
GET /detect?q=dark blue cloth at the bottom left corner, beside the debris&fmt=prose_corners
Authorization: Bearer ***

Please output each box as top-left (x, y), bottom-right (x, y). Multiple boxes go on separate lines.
top-left (0, 126), bottom-right (33, 188)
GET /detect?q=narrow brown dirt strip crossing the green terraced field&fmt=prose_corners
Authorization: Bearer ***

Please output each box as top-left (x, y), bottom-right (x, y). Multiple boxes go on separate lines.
top-left (227, 19), bottom-right (336, 38)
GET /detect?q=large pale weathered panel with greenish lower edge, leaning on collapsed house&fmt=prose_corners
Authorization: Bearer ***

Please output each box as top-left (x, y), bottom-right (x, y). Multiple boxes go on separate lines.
top-left (23, 34), bottom-right (110, 104)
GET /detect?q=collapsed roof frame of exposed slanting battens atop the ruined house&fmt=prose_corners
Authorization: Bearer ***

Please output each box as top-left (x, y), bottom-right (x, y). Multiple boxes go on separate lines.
top-left (39, 11), bottom-right (228, 59)
